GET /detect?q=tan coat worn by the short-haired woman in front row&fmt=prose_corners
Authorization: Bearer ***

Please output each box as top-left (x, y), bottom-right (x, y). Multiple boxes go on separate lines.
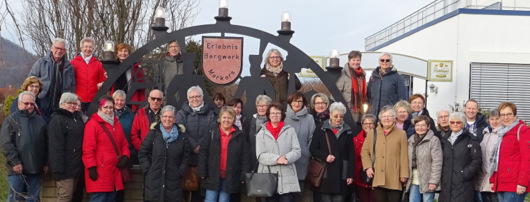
top-left (361, 126), bottom-right (409, 191)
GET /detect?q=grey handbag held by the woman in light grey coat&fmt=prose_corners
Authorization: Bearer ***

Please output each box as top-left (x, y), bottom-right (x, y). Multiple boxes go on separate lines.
top-left (245, 154), bottom-right (278, 197)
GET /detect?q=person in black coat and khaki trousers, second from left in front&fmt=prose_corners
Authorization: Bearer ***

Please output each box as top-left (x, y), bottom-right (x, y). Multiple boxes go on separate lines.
top-left (48, 93), bottom-right (85, 201)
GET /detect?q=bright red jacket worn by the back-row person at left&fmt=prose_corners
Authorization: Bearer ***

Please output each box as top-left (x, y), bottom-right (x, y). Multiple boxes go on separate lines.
top-left (70, 54), bottom-right (107, 102)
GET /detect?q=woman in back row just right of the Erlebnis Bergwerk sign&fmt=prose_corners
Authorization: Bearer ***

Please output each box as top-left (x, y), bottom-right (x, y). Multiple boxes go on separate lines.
top-left (261, 49), bottom-right (302, 103)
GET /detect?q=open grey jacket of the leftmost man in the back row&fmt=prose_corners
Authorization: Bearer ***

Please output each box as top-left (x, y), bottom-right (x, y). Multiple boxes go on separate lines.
top-left (29, 52), bottom-right (75, 98)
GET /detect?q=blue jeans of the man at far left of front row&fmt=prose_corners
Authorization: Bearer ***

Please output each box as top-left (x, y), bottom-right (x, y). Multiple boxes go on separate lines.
top-left (7, 174), bottom-right (40, 202)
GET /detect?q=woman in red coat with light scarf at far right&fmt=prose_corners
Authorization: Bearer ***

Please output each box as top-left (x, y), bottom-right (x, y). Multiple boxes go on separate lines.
top-left (488, 102), bottom-right (530, 202)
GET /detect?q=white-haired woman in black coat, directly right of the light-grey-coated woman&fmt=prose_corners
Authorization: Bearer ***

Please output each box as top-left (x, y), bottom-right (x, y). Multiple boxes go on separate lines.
top-left (310, 102), bottom-right (355, 202)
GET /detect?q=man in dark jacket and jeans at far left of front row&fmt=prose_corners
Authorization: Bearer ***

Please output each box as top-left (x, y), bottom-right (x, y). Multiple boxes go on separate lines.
top-left (0, 91), bottom-right (48, 202)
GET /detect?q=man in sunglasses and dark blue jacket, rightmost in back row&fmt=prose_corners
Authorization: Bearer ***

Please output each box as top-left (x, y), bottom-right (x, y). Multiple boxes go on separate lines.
top-left (367, 53), bottom-right (408, 117)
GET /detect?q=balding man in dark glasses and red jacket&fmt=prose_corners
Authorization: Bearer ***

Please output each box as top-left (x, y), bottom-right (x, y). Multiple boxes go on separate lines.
top-left (131, 89), bottom-right (164, 151)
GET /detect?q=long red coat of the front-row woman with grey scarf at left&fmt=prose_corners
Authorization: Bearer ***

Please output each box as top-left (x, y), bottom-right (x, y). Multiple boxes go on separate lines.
top-left (83, 113), bottom-right (130, 193)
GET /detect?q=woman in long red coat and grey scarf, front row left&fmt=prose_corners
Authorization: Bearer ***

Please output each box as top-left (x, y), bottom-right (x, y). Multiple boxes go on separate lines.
top-left (83, 95), bottom-right (130, 201)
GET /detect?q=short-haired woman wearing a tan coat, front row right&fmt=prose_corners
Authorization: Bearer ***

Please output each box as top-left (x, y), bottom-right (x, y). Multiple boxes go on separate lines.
top-left (361, 106), bottom-right (410, 202)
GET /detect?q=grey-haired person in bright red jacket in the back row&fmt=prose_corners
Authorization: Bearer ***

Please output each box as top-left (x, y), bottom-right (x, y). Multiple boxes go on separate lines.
top-left (70, 37), bottom-right (107, 112)
